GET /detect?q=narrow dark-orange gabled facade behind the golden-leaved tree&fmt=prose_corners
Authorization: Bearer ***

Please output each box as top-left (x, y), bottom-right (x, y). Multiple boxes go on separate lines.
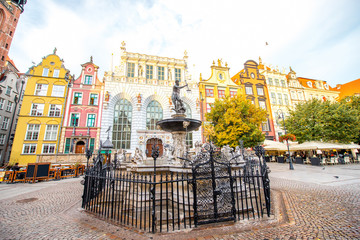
top-left (231, 60), bottom-right (275, 140)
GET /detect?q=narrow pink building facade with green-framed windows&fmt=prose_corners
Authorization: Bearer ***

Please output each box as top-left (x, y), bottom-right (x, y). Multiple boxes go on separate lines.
top-left (59, 57), bottom-right (104, 154)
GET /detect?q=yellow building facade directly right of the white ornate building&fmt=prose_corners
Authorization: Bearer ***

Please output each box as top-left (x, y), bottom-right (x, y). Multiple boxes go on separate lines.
top-left (199, 59), bottom-right (242, 142)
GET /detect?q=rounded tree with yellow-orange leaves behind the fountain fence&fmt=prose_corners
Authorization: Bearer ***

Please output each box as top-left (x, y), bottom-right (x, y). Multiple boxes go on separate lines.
top-left (205, 96), bottom-right (267, 147)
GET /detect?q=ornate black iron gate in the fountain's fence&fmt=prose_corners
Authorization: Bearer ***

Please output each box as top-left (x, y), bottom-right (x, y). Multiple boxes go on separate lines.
top-left (192, 149), bottom-right (236, 226)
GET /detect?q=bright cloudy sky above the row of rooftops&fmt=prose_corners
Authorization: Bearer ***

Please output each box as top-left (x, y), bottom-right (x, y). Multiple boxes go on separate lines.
top-left (10, 0), bottom-right (360, 87)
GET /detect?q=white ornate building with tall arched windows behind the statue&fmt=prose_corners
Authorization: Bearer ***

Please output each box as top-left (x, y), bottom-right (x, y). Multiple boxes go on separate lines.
top-left (100, 42), bottom-right (201, 156)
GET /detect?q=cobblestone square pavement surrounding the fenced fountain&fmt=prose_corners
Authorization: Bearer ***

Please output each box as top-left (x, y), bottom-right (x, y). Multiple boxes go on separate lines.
top-left (0, 163), bottom-right (360, 240)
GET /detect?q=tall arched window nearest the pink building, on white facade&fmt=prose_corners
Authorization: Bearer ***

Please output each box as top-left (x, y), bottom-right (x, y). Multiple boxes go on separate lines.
top-left (112, 99), bottom-right (132, 149)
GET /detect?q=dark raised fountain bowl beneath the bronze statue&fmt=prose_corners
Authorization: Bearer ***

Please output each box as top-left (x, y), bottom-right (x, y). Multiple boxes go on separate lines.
top-left (156, 117), bottom-right (201, 132)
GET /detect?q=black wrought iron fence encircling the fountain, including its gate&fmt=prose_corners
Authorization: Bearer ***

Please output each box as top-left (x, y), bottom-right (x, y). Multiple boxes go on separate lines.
top-left (82, 142), bottom-right (270, 233)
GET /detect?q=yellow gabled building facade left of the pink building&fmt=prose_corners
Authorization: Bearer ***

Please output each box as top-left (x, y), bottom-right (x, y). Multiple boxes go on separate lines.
top-left (10, 49), bottom-right (69, 165)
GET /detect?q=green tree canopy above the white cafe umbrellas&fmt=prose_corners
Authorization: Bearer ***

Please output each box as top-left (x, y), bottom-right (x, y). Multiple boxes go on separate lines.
top-left (286, 99), bottom-right (360, 143)
